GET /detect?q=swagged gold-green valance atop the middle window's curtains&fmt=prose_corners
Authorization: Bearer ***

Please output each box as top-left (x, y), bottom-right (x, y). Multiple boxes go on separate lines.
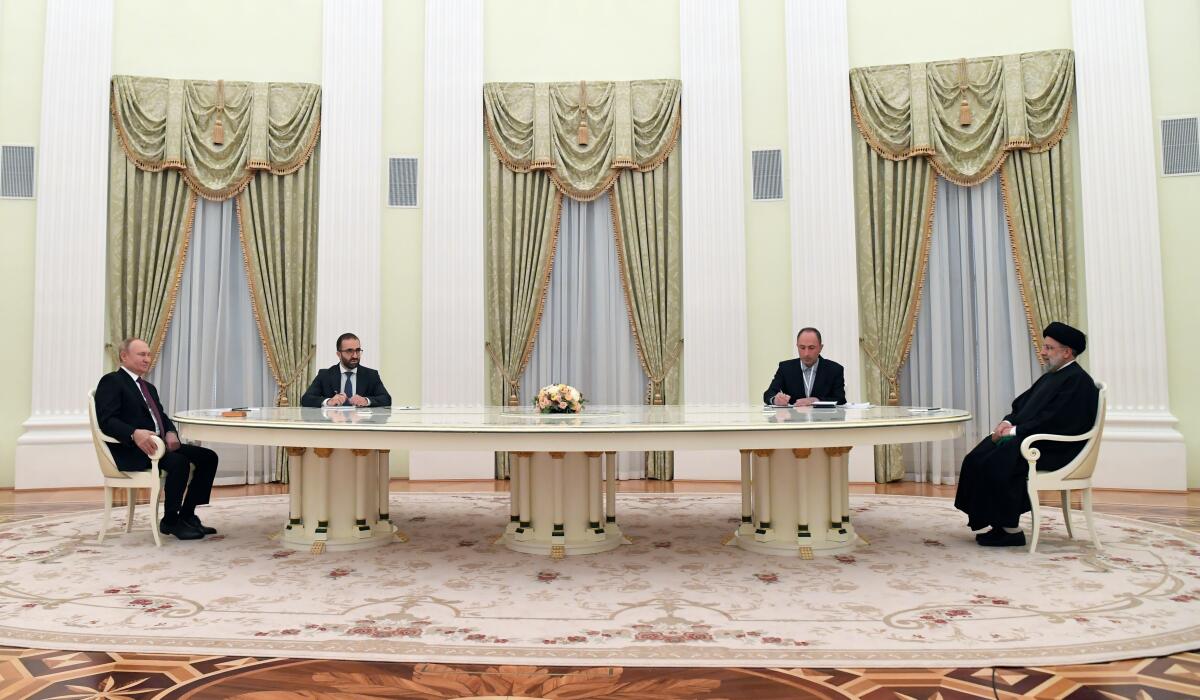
top-left (484, 80), bottom-right (680, 201)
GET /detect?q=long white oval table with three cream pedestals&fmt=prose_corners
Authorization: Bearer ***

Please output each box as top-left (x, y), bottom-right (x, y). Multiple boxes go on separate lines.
top-left (174, 405), bottom-right (971, 558)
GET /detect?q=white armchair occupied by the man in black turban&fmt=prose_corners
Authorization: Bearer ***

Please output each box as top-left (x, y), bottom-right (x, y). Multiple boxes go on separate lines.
top-left (1021, 382), bottom-right (1108, 554)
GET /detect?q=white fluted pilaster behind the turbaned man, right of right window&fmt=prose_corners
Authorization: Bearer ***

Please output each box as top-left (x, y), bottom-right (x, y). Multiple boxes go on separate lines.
top-left (1072, 0), bottom-right (1187, 489)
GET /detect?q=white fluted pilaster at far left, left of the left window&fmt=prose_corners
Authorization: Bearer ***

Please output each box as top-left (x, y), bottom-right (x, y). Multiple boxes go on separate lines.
top-left (16, 0), bottom-right (113, 489)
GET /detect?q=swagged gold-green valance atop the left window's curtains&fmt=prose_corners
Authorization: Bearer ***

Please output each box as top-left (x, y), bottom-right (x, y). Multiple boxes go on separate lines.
top-left (112, 76), bottom-right (320, 201)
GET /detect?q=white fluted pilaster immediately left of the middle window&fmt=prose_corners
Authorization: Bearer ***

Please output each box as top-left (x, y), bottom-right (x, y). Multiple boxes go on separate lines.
top-left (410, 0), bottom-right (492, 478)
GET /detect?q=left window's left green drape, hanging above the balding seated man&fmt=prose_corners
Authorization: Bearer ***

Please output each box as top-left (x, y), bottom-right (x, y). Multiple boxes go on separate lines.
top-left (106, 130), bottom-right (196, 365)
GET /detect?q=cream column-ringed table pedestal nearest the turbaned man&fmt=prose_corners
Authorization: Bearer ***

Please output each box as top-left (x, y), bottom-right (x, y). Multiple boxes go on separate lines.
top-left (726, 447), bottom-right (866, 558)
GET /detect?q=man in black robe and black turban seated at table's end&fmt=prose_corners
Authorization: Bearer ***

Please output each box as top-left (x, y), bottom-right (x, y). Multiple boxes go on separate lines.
top-left (954, 321), bottom-right (1099, 546)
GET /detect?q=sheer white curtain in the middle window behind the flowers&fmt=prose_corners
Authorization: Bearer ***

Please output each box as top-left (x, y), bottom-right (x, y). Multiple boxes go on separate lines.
top-left (521, 195), bottom-right (646, 479)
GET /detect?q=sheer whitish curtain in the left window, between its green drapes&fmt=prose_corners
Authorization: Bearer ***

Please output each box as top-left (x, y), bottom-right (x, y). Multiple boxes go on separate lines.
top-left (151, 194), bottom-right (278, 484)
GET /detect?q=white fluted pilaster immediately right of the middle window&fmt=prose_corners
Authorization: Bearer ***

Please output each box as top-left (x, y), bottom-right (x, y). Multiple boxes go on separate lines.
top-left (676, 0), bottom-right (749, 479)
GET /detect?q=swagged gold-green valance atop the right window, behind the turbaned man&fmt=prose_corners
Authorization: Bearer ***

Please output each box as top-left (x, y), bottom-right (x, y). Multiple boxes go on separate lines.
top-left (850, 49), bottom-right (1075, 186)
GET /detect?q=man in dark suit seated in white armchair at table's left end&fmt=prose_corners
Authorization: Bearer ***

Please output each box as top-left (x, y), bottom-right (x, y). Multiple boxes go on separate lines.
top-left (96, 337), bottom-right (217, 539)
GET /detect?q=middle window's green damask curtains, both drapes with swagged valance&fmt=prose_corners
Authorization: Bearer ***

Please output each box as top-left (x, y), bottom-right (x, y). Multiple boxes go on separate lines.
top-left (484, 80), bottom-right (683, 478)
